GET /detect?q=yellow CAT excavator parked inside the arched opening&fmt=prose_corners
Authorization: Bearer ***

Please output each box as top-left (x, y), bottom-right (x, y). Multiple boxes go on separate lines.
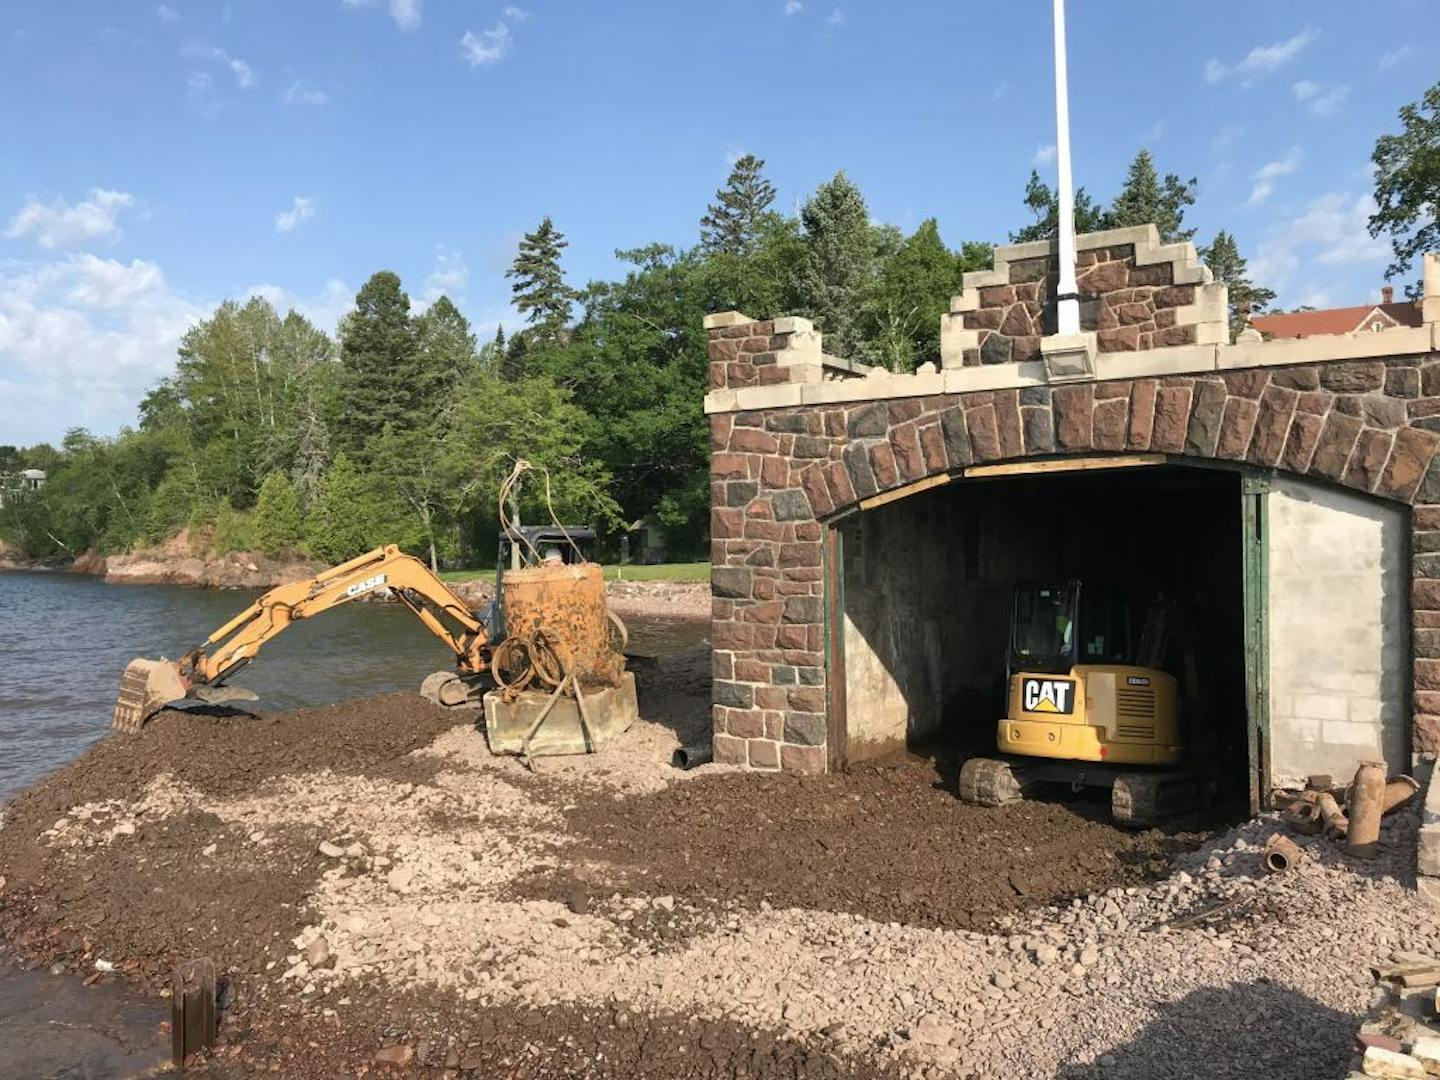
top-left (960, 580), bottom-right (1200, 827)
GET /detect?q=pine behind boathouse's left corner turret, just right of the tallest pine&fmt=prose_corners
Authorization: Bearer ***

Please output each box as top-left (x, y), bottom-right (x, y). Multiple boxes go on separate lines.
top-left (801, 171), bottom-right (874, 356)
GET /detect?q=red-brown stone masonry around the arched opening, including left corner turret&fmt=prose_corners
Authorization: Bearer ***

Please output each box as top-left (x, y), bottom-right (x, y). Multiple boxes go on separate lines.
top-left (710, 316), bottom-right (1440, 772)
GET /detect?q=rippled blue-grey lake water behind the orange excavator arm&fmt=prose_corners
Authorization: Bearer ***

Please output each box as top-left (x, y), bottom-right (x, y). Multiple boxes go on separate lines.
top-left (0, 573), bottom-right (708, 799)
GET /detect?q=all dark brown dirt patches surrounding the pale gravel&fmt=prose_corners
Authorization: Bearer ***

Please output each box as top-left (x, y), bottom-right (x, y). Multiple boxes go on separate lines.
top-left (0, 661), bottom-right (1215, 1080)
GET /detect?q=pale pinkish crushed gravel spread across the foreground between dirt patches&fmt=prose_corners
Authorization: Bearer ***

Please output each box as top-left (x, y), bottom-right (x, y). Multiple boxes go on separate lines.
top-left (30, 732), bottom-right (1440, 1080)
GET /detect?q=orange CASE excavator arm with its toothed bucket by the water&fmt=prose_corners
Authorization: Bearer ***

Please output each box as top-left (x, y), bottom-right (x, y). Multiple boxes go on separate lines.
top-left (111, 544), bottom-right (490, 733)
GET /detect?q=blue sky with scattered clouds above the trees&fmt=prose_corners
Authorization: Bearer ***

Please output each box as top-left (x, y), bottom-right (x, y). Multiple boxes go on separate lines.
top-left (0, 0), bottom-right (1440, 444)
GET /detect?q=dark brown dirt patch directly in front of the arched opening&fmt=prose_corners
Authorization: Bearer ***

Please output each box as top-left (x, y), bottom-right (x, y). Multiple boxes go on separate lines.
top-left (527, 759), bottom-right (1207, 930)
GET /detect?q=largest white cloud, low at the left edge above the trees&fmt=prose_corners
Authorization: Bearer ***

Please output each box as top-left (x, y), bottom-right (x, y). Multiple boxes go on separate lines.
top-left (0, 253), bottom-right (204, 444)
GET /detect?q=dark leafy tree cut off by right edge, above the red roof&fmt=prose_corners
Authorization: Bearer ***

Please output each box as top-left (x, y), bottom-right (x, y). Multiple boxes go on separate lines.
top-left (1369, 82), bottom-right (1440, 289)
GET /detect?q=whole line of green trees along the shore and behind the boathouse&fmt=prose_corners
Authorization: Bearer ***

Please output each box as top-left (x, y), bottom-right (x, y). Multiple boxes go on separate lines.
top-left (0, 85), bottom-right (1440, 564)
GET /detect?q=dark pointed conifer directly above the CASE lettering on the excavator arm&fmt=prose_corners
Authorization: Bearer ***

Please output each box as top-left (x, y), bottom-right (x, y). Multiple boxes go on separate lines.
top-left (338, 271), bottom-right (422, 462)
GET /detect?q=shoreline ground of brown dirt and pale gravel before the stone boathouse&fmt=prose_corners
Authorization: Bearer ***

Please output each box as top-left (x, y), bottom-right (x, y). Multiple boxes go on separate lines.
top-left (0, 649), bottom-right (1422, 1080)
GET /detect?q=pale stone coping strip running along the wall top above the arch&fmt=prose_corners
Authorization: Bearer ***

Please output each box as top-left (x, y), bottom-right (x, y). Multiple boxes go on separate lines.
top-left (706, 324), bottom-right (1440, 413)
